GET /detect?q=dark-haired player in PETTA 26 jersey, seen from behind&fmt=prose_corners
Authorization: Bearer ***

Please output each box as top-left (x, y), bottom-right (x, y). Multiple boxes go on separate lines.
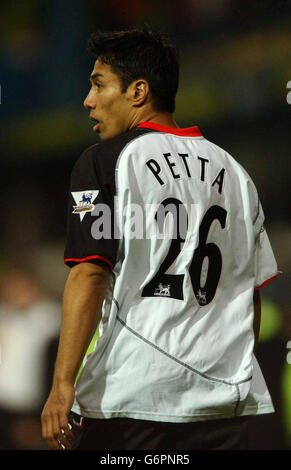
top-left (42, 27), bottom-right (277, 450)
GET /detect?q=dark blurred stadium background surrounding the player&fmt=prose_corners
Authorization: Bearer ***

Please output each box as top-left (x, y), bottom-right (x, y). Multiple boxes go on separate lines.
top-left (0, 0), bottom-right (291, 450)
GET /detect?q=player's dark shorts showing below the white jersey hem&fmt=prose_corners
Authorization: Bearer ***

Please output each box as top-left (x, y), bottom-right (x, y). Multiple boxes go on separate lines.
top-left (70, 413), bottom-right (248, 450)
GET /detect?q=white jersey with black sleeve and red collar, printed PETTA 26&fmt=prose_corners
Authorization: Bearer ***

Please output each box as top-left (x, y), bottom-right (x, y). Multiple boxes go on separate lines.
top-left (65, 123), bottom-right (277, 422)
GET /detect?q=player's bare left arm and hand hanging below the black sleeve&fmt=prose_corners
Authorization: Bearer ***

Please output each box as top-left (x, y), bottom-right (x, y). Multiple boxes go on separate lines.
top-left (41, 263), bottom-right (109, 450)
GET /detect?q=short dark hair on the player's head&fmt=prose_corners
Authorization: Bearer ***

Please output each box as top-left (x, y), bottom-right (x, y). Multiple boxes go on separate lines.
top-left (88, 25), bottom-right (179, 113)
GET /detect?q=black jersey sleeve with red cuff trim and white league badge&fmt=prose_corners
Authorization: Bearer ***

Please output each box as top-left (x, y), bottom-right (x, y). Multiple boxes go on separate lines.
top-left (64, 145), bottom-right (118, 269)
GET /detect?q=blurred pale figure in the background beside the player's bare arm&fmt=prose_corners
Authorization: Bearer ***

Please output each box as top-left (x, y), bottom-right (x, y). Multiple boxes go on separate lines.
top-left (0, 262), bottom-right (61, 450)
